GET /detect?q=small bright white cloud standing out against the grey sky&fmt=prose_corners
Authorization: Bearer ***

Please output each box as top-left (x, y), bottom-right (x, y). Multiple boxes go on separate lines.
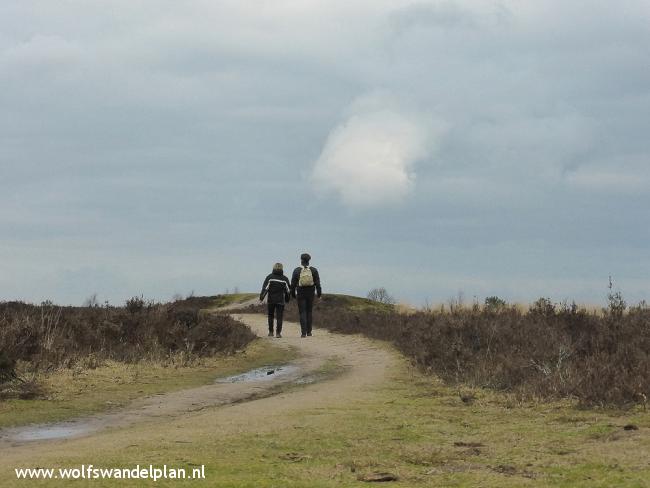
top-left (312, 94), bottom-right (435, 207)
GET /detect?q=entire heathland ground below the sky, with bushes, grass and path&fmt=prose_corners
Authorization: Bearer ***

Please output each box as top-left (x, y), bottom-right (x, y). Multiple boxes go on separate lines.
top-left (0, 294), bottom-right (650, 487)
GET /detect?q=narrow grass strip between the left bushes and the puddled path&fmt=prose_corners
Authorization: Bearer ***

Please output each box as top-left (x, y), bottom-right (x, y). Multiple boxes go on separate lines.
top-left (0, 340), bottom-right (296, 428)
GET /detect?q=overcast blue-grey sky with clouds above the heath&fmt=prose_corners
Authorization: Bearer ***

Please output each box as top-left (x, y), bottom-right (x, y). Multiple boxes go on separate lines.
top-left (0, 0), bottom-right (650, 305)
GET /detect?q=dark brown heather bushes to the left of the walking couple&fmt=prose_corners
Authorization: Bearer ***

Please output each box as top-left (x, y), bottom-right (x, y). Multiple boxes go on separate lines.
top-left (0, 297), bottom-right (254, 383)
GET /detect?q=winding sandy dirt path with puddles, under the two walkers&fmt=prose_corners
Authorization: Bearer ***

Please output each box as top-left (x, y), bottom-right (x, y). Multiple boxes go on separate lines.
top-left (0, 314), bottom-right (399, 456)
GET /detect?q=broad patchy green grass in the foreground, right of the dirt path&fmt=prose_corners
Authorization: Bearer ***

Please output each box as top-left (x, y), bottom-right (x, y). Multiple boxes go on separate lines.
top-left (0, 363), bottom-right (650, 488)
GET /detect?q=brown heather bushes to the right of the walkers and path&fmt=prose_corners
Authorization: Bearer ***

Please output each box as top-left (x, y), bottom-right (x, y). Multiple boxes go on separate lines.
top-left (264, 296), bottom-right (650, 405)
